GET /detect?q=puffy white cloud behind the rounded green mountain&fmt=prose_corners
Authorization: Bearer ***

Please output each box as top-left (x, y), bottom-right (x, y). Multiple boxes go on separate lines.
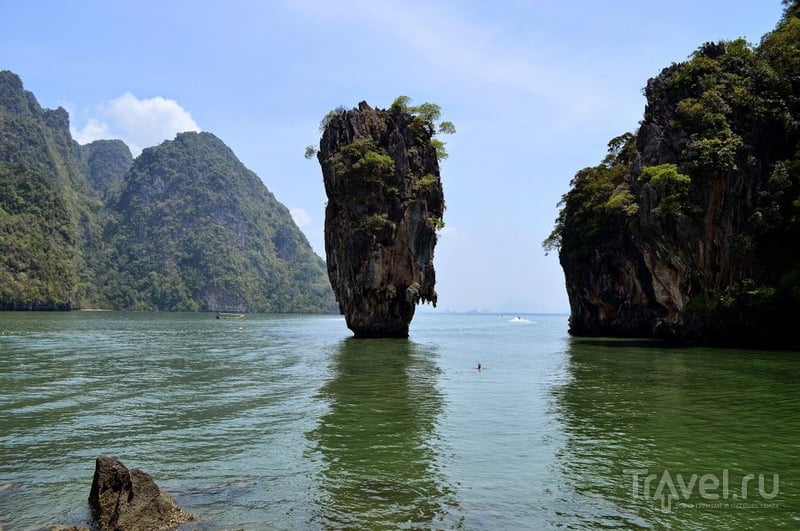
top-left (72, 92), bottom-right (200, 156)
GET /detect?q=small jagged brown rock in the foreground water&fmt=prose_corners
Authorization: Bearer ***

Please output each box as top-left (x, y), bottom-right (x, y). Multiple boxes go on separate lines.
top-left (89, 457), bottom-right (196, 531)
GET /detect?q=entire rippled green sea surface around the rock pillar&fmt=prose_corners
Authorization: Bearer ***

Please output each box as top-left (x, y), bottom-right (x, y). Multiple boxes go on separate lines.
top-left (0, 312), bottom-right (800, 530)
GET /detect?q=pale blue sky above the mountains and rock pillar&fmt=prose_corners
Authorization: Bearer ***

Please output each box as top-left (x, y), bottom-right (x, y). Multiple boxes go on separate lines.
top-left (0, 0), bottom-right (783, 313)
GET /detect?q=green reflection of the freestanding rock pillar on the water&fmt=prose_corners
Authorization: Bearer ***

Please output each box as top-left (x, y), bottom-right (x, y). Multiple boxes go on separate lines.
top-left (309, 339), bottom-right (448, 529)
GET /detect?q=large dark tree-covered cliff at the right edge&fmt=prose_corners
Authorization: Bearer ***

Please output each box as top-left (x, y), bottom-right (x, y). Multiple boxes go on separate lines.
top-left (545, 1), bottom-right (800, 345)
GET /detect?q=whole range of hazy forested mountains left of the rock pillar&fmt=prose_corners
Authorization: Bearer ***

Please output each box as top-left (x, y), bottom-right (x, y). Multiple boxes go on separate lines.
top-left (0, 71), bottom-right (336, 313)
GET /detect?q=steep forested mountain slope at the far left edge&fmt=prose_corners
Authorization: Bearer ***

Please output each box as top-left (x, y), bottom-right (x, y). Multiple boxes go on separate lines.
top-left (0, 71), bottom-right (102, 309)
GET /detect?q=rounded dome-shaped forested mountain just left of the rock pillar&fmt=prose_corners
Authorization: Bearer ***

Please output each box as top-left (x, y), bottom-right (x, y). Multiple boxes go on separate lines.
top-left (104, 133), bottom-right (334, 312)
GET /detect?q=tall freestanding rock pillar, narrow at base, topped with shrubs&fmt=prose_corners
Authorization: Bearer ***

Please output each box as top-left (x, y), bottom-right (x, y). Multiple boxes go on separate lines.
top-left (317, 102), bottom-right (444, 337)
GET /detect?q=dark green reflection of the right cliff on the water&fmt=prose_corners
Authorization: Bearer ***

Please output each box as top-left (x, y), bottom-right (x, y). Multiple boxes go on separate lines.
top-left (553, 339), bottom-right (800, 529)
